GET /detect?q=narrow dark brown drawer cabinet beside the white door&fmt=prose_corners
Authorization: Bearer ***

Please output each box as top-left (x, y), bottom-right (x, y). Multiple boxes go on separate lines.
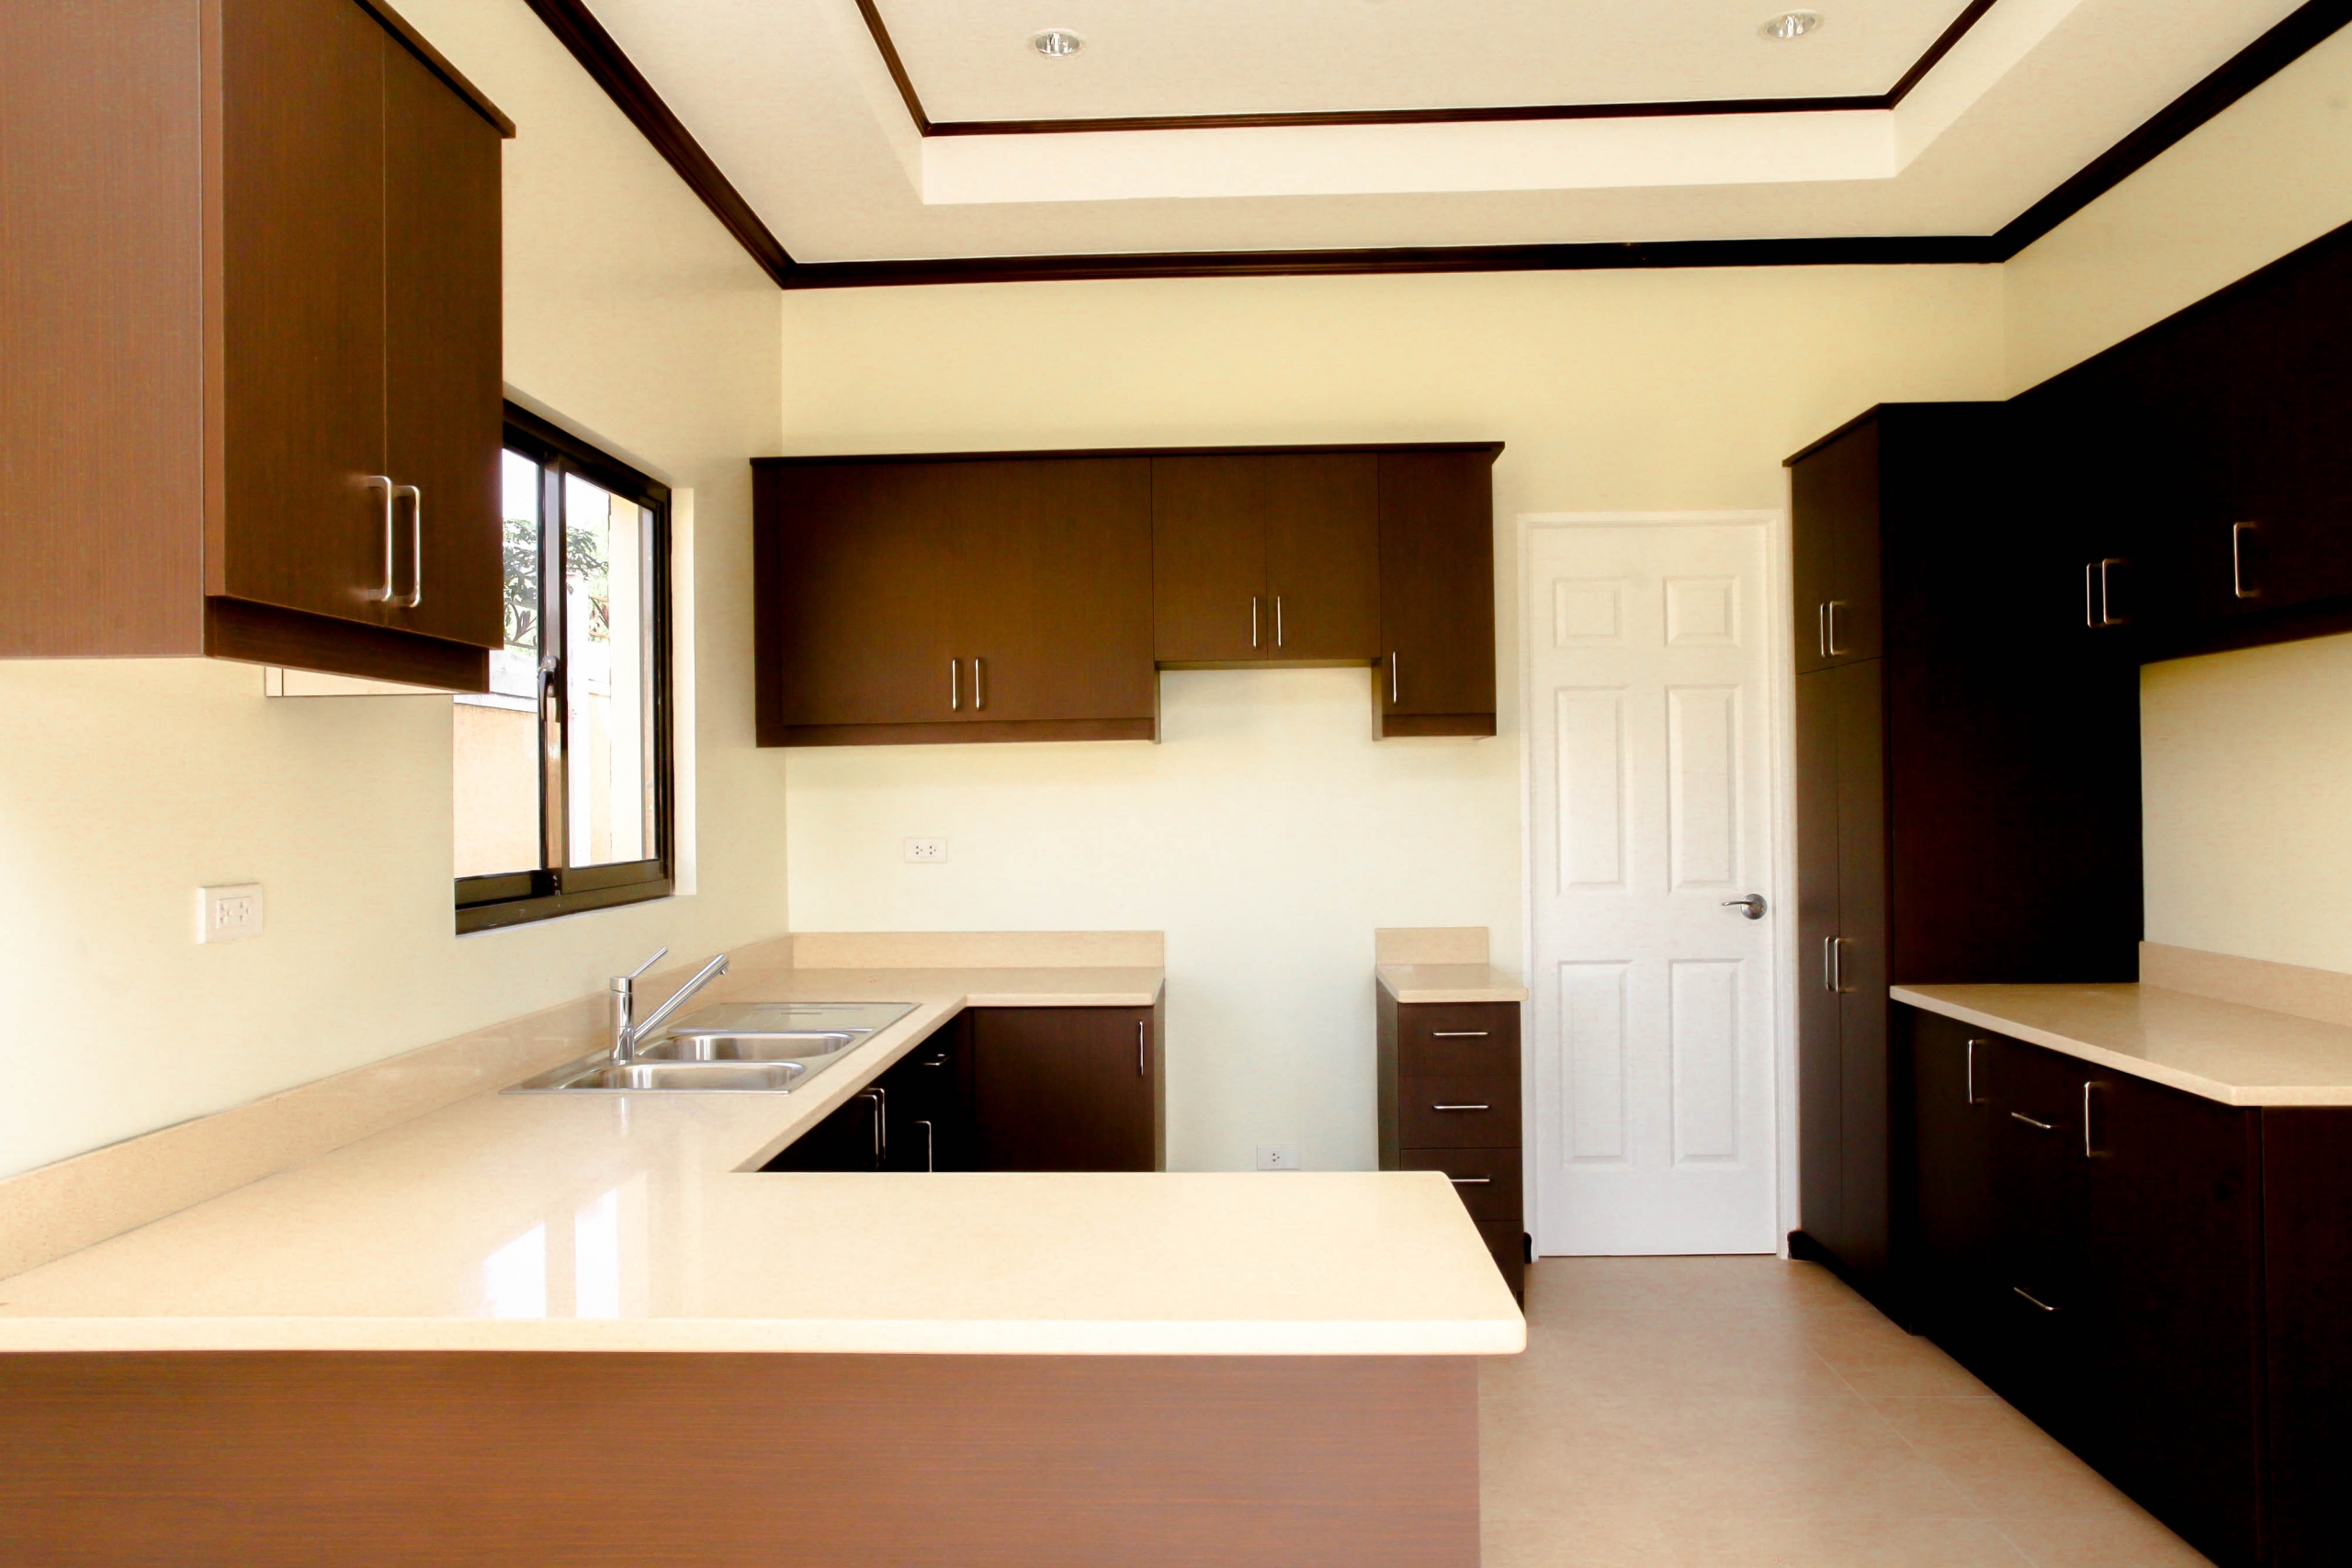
top-left (1378, 985), bottom-right (1526, 1300)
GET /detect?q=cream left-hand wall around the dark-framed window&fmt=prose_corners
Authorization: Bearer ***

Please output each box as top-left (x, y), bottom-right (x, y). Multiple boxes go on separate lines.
top-left (0, 0), bottom-right (786, 1173)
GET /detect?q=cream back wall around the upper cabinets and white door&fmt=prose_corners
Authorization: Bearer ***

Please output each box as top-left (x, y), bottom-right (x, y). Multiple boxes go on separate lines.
top-left (783, 268), bottom-right (2002, 1168)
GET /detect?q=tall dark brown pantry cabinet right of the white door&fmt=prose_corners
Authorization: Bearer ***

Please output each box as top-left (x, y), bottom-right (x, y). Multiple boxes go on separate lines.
top-left (1788, 404), bottom-right (2141, 1319)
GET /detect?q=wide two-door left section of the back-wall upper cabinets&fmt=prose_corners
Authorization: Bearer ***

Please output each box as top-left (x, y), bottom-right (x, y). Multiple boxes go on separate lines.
top-left (752, 456), bottom-right (1159, 745)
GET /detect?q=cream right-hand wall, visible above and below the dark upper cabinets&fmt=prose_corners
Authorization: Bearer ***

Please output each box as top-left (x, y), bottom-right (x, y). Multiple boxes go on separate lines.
top-left (2004, 15), bottom-right (2352, 971)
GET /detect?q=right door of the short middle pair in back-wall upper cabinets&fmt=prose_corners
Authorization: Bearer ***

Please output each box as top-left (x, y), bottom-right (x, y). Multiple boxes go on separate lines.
top-left (1263, 451), bottom-right (1381, 660)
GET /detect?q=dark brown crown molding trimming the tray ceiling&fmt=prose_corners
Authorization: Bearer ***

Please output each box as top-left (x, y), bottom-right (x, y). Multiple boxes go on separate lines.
top-left (529, 0), bottom-right (2352, 289)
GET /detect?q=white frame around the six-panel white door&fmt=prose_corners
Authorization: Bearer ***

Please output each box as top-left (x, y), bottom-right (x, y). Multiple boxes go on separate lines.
top-left (1512, 508), bottom-right (1797, 1258)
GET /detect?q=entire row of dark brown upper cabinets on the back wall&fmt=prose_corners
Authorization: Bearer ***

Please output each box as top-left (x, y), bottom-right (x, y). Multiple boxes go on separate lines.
top-left (752, 442), bottom-right (1500, 745)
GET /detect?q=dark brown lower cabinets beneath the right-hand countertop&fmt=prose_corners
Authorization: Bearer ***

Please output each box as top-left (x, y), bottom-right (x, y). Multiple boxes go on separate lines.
top-left (1900, 1009), bottom-right (2277, 1563)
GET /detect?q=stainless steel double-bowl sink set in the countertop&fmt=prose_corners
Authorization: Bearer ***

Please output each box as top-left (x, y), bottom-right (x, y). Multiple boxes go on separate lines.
top-left (505, 1001), bottom-right (915, 1093)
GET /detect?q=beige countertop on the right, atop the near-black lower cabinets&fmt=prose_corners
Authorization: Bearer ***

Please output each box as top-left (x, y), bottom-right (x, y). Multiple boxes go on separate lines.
top-left (1889, 985), bottom-right (2352, 1105)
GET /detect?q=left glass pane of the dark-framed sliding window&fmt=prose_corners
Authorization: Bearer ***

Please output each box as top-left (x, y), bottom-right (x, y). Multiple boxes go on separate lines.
top-left (452, 451), bottom-right (546, 877)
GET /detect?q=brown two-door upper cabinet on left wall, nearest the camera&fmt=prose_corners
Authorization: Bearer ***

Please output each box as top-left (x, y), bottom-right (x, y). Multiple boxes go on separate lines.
top-left (0, 0), bottom-right (513, 689)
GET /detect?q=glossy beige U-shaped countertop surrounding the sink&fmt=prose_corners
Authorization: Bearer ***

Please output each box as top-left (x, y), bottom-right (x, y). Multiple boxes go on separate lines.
top-left (0, 968), bottom-right (1524, 1354)
